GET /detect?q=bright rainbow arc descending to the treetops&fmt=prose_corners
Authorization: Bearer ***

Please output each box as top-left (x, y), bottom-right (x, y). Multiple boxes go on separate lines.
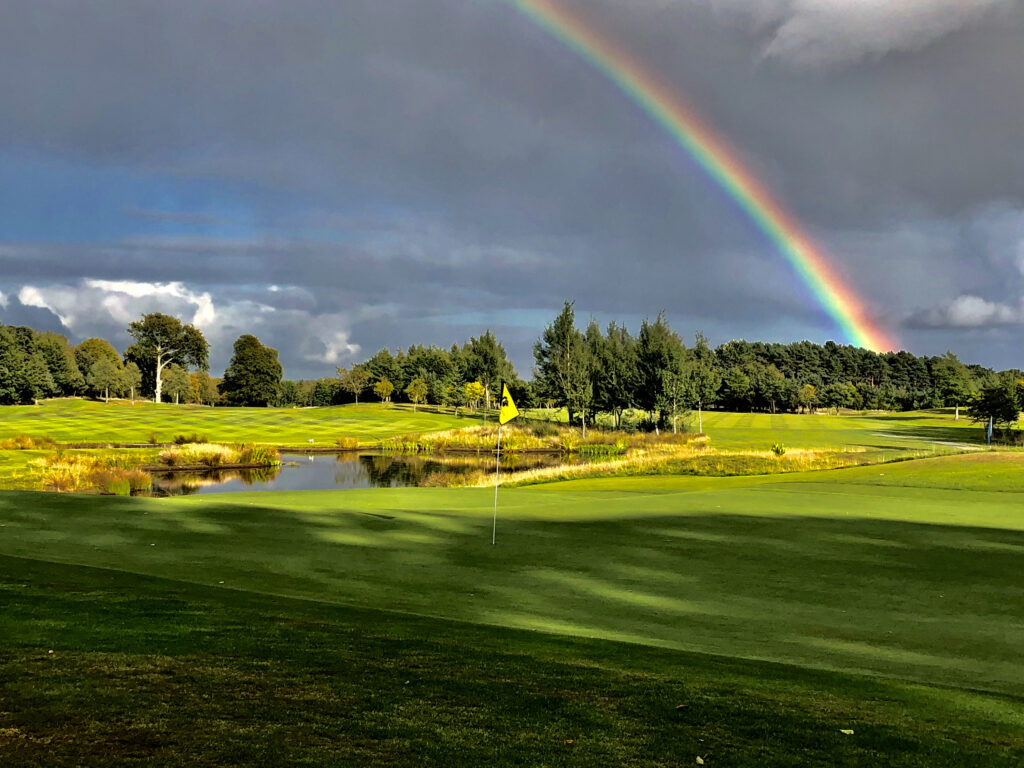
top-left (507, 0), bottom-right (896, 352)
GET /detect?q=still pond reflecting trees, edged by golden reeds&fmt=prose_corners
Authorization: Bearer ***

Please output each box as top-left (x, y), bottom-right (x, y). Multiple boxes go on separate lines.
top-left (153, 453), bottom-right (577, 496)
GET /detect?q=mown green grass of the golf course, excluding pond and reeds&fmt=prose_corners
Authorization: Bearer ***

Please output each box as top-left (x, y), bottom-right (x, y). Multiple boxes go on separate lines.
top-left (0, 400), bottom-right (1024, 767)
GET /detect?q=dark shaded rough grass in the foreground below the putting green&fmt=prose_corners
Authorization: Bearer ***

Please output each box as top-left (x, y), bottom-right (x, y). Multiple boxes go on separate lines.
top-left (8, 557), bottom-right (1024, 768)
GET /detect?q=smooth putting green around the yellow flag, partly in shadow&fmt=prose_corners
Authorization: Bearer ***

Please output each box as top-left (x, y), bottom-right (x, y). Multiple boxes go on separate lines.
top-left (0, 454), bottom-right (1024, 696)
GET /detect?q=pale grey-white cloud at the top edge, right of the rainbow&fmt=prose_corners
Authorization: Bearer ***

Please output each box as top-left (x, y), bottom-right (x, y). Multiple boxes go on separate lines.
top-left (714, 0), bottom-right (1003, 67)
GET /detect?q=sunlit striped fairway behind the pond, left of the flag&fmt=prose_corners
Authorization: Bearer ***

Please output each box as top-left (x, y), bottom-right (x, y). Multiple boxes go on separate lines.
top-left (0, 399), bottom-right (476, 447)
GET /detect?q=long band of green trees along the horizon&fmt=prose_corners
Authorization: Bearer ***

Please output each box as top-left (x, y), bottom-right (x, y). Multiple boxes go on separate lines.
top-left (0, 302), bottom-right (1024, 428)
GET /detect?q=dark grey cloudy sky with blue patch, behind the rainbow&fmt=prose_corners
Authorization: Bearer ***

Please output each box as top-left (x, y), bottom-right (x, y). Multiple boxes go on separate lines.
top-left (0, 0), bottom-right (1024, 378)
